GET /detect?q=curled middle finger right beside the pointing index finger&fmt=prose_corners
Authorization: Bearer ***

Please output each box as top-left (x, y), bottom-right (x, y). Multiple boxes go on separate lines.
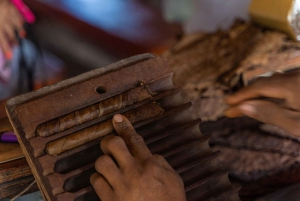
top-left (100, 135), bottom-right (134, 169)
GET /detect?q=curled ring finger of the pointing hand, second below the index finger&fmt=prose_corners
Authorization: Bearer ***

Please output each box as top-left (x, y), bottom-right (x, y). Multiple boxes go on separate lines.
top-left (95, 155), bottom-right (122, 187)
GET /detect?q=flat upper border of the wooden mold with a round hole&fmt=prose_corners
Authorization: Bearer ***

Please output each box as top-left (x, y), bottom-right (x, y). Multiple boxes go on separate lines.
top-left (8, 53), bottom-right (172, 139)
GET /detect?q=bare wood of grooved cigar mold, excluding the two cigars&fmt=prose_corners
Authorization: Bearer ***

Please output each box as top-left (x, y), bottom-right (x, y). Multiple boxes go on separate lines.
top-left (6, 54), bottom-right (239, 201)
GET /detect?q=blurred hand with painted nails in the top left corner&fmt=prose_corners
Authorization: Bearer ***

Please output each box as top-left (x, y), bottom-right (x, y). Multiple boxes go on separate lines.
top-left (0, 0), bottom-right (26, 59)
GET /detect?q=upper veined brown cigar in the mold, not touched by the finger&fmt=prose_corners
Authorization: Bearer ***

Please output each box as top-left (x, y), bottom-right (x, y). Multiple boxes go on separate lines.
top-left (36, 86), bottom-right (153, 137)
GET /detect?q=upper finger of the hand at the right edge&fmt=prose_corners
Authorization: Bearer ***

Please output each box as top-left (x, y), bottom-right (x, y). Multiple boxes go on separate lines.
top-left (225, 75), bottom-right (288, 105)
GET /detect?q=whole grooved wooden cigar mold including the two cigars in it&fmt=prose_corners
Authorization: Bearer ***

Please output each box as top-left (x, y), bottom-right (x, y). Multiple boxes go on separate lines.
top-left (6, 54), bottom-right (239, 201)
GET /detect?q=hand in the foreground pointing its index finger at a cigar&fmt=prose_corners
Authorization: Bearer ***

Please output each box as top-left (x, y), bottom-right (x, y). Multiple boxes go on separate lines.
top-left (90, 114), bottom-right (186, 201)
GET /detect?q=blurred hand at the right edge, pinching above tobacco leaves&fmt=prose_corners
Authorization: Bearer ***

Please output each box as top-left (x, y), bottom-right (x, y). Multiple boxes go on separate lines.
top-left (225, 70), bottom-right (300, 137)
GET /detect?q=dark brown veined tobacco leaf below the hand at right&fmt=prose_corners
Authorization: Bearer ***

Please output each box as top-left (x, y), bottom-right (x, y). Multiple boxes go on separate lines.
top-left (200, 117), bottom-right (300, 188)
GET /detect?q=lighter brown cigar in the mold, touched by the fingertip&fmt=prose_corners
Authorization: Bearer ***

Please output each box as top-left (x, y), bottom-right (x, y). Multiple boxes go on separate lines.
top-left (45, 102), bottom-right (164, 156)
